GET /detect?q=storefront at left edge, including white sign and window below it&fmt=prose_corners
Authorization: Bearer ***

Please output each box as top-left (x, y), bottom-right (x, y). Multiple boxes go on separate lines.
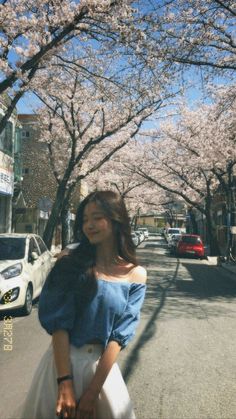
top-left (0, 151), bottom-right (14, 233)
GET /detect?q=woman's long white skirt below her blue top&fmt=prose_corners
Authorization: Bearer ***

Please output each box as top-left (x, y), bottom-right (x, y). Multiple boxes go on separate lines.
top-left (17, 344), bottom-right (135, 419)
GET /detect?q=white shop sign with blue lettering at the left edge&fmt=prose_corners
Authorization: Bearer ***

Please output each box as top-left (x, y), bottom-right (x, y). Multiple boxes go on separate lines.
top-left (0, 151), bottom-right (14, 195)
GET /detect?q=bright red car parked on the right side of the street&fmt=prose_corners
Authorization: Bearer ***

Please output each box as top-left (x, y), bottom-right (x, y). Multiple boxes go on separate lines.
top-left (176, 234), bottom-right (205, 259)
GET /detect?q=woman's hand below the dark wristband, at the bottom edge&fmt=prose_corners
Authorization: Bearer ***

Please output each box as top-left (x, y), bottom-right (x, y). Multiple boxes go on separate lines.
top-left (56, 380), bottom-right (76, 419)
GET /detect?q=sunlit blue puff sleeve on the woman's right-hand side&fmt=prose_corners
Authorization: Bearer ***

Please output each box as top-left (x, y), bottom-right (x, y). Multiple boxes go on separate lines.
top-left (109, 283), bottom-right (146, 349)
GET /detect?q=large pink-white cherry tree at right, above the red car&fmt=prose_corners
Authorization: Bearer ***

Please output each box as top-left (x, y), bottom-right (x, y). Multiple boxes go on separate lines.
top-left (127, 86), bottom-right (236, 254)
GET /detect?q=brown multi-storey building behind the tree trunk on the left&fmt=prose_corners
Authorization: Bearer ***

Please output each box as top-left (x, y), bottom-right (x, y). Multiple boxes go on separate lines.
top-left (14, 114), bottom-right (83, 245)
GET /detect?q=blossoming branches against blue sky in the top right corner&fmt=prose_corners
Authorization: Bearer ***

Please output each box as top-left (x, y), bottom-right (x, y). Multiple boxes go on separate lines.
top-left (150, 0), bottom-right (236, 76)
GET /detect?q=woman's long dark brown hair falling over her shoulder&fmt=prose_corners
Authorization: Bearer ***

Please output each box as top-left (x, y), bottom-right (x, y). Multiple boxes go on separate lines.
top-left (49, 190), bottom-right (137, 299)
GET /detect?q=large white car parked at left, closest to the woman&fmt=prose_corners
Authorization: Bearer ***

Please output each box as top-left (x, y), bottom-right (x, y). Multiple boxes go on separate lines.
top-left (0, 233), bottom-right (55, 315)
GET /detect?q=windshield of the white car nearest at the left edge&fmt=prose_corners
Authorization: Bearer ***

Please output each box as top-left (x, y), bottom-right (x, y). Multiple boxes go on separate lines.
top-left (0, 237), bottom-right (26, 260)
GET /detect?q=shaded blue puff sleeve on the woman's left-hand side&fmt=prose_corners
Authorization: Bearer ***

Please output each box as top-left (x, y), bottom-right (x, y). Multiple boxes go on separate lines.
top-left (38, 261), bottom-right (76, 335)
